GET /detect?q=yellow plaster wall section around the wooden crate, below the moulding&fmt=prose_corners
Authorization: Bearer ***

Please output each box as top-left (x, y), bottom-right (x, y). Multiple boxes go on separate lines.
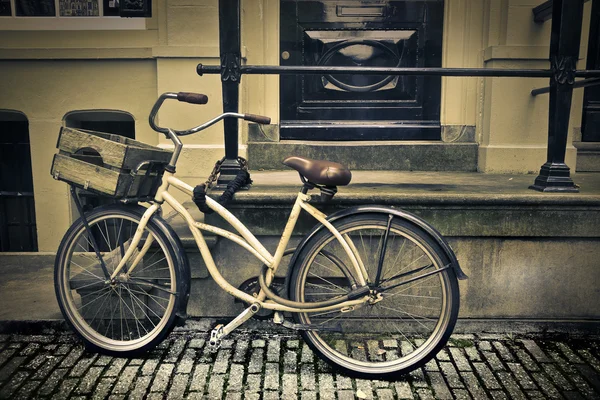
top-left (0, 60), bottom-right (157, 251)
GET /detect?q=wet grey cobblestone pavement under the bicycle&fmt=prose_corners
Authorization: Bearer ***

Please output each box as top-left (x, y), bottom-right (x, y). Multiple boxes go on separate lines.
top-left (0, 322), bottom-right (600, 399)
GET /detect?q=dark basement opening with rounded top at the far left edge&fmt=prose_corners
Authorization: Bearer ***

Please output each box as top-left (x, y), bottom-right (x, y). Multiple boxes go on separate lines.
top-left (0, 121), bottom-right (37, 251)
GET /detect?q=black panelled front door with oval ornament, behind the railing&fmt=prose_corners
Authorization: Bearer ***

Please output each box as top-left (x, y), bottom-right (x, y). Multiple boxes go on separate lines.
top-left (280, 0), bottom-right (444, 140)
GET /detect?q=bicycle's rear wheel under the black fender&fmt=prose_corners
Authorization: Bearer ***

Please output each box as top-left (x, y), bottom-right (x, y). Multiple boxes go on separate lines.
top-left (290, 213), bottom-right (459, 379)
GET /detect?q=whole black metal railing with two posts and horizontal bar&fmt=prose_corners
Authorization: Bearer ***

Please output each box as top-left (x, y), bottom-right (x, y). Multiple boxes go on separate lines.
top-left (207, 0), bottom-right (600, 192)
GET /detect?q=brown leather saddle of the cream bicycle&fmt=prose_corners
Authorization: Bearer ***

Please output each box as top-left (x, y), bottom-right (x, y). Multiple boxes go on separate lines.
top-left (283, 156), bottom-right (352, 186)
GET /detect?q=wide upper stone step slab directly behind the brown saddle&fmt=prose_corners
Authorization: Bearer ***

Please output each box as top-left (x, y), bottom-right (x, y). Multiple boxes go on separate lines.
top-left (185, 171), bottom-right (600, 239)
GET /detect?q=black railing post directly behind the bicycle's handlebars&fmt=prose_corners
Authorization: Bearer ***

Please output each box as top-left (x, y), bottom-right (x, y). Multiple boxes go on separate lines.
top-left (217, 0), bottom-right (241, 186)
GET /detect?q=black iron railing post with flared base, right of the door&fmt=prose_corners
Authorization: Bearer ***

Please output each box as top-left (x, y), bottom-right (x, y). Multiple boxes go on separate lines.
top-left (529, 0), bottom-right (583, 192)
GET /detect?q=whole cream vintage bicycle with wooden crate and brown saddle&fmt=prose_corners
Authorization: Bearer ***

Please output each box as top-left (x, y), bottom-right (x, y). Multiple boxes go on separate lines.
top-left (52, 92), bottom-right (465, 379)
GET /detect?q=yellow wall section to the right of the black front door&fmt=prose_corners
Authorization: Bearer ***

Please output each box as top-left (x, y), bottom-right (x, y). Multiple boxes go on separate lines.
top-left (477, 0), bottom-right (591, 173)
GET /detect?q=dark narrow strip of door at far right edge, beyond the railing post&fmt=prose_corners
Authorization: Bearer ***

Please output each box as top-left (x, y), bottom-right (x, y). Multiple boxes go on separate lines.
top-left (581, 0), bottom-right (600, 142)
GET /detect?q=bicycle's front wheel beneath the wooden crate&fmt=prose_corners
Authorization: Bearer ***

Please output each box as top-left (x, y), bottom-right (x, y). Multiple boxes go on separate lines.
top-left (54, 206), bottom-right (181, 356)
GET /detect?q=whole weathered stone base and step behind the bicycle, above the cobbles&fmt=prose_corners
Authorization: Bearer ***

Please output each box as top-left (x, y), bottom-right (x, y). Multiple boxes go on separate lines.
top-left (0, 171), bottom-right (600, 324)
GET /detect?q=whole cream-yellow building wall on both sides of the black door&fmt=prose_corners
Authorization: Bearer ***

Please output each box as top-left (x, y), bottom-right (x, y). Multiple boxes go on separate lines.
top-left (0, 0), bottom-right (591, 251)
